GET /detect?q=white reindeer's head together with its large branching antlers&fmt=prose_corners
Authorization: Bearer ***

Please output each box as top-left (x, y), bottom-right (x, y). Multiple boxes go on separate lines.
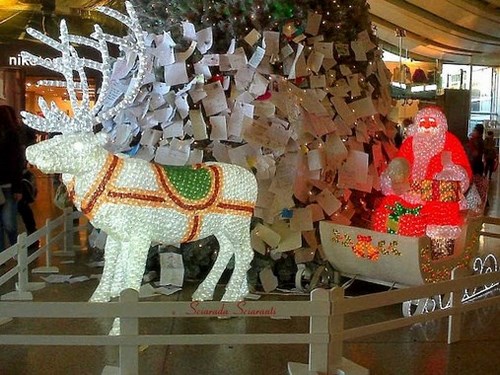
top-left (21, 2), bottom-right (147, 174)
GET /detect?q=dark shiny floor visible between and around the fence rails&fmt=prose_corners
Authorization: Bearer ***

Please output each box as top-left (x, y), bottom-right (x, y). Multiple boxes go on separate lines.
top-left (0, 172), bottom-right (500, 375)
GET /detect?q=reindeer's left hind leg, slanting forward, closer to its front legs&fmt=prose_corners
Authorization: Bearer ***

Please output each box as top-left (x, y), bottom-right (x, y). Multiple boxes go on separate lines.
top-left (192, 233), bottom-right (233, 301)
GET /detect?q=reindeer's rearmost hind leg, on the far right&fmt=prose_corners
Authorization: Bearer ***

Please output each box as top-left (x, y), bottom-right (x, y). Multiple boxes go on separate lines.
top-left (222, 218), bottom-right (253, 301)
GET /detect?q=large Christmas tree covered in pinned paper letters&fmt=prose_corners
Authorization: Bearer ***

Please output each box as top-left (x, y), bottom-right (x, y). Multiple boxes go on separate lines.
top-left (103, 0), bottom-right (394, 287)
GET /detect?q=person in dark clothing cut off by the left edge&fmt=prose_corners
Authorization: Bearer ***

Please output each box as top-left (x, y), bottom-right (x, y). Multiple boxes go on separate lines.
top-left (0, 105), bottom-right (24, 251)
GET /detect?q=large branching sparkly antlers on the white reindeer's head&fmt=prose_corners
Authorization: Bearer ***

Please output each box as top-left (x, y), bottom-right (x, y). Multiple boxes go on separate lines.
top-left (21, 2), bottom-right (147, 133)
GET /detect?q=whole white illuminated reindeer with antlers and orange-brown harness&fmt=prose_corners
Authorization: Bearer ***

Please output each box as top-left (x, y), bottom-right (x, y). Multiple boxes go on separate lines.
top-left (23, 3), bottom-right (257, 333)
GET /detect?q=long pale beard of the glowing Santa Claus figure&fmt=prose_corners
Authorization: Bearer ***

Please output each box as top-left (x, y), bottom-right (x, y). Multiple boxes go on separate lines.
top-left (411, 132), bottom-right (445, 180)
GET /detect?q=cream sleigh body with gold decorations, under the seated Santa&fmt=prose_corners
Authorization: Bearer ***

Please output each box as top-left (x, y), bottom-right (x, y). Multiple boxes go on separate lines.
top-left (320, 218), bottom-right (482, 287)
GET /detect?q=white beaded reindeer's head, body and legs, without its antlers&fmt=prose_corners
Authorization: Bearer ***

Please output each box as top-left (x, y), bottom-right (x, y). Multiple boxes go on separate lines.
top-left (26, 133), bottom-right (257, 302)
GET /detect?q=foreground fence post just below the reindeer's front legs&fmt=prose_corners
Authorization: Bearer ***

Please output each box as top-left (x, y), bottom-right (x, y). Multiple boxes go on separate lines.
top-left (119, 289), bottom-right (139, 375)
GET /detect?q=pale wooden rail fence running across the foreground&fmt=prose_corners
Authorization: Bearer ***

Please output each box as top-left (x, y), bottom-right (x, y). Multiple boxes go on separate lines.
top-left (0, 213), bottom-right (500, 375)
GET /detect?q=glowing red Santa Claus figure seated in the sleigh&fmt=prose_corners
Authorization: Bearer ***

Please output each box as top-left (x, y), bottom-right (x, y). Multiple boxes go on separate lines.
top-left (373, 107), bottom-right (472, 256)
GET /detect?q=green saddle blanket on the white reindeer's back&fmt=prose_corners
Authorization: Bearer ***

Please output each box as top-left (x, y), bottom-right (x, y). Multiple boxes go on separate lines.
top-left (163, 166), bottom-right (213, 201)
